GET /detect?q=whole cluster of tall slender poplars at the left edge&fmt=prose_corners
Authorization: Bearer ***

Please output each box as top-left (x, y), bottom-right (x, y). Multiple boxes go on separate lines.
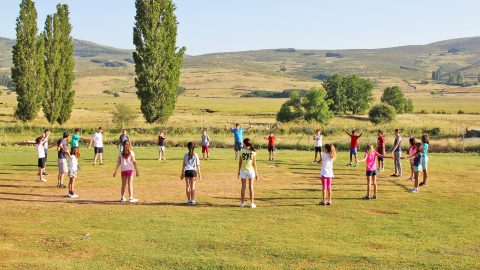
top-left (12, 0), bottom-right (75, 124)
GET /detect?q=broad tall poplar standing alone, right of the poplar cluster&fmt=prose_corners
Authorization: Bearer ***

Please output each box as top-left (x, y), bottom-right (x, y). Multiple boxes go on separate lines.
top-left (133, 0), bottom-right (186, 123)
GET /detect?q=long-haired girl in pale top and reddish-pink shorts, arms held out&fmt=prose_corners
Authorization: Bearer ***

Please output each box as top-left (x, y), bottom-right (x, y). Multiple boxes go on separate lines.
top-left (113, 141), bottom-right (140, 203)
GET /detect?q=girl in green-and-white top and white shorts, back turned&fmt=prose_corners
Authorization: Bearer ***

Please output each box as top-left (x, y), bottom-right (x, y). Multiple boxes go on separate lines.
top-left (238, 138), bottom-right (260, 208)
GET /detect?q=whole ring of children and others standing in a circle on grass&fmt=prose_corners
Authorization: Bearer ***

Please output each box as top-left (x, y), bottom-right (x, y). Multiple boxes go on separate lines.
top-left (25, 124), bottom-right (429, 208)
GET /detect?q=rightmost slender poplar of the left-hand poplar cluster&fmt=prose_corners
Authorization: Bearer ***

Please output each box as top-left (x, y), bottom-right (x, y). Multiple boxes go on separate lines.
top-left (57, 4), bottom-right (75, 125)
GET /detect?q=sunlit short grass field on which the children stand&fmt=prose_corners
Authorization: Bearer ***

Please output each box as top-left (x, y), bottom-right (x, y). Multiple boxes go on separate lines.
top-left (0, 147), bottom-right (480, 269)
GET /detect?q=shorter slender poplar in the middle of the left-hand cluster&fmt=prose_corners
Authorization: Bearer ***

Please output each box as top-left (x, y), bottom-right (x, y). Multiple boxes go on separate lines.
top-left (43, 14), bottom-right (64, 124)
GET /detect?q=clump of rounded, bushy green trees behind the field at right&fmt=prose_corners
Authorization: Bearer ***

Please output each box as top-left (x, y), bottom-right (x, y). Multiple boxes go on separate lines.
top-left (277, 74), bottom-right (413, 125)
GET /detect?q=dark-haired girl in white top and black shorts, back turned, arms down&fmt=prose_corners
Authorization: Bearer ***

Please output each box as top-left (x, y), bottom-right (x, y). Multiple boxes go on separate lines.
top-left (180, 142), bottom-right (202, 205)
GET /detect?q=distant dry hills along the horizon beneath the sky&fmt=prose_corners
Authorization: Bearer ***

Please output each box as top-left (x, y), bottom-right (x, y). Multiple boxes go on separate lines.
top-left (0, 37), bottom-right (480, 80)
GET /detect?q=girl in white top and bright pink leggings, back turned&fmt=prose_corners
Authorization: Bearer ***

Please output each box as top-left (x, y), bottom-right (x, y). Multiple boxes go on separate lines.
top-left (318, 144), bottom-right (337, 205)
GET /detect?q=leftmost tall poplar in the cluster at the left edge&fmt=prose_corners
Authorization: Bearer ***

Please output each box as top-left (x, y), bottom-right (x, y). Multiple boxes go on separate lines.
top-left (12, 0), bottom-right (45, 122)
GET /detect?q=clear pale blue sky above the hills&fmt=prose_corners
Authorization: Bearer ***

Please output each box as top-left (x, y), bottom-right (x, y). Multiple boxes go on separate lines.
top-left (0, 0), bottom-right (480, 55)
